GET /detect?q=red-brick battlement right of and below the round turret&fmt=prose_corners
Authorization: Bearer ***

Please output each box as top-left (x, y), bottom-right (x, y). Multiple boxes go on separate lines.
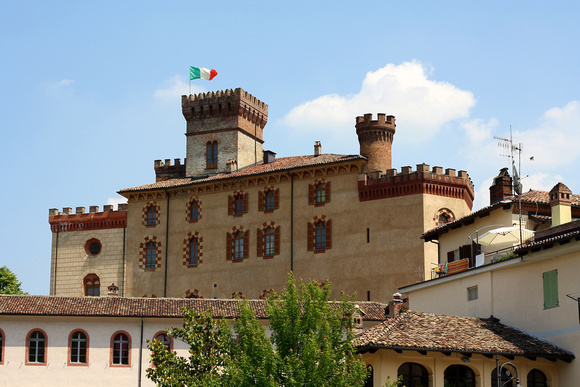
top-left (358, 164), bottom-right (475, 208)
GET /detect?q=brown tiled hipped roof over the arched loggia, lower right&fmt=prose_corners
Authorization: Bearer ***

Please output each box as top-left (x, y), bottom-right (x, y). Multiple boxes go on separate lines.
top-left (354, 311), bottom-right (574, 361)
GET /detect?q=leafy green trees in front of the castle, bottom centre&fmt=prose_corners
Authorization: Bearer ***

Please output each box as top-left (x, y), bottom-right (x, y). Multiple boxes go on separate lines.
top-left (147, 275), bottom-right (367, 387)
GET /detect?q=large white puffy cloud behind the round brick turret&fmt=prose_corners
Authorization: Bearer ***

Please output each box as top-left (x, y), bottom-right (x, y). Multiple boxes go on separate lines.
top-left (282, 61), bottom-right (475, 146)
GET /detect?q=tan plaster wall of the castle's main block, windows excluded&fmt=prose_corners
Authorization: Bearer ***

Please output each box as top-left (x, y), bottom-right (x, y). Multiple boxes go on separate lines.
top-left (127, 172), bottom-right (469, 301)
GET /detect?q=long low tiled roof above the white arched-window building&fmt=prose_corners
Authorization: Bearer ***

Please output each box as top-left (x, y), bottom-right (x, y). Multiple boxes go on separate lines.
top-left (0, 295), bottom-right (386, 321)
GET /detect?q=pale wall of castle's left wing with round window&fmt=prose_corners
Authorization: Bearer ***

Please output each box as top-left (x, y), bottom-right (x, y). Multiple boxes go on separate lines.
top-left (50, 228), bottom-right (124, 296)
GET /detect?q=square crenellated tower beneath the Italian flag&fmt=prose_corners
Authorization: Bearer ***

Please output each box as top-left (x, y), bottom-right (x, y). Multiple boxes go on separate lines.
top-left (181, 88), bottom-right (268, 176)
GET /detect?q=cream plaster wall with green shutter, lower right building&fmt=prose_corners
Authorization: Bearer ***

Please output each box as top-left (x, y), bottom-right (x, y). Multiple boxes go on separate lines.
top-left (407, 241), bottom-right (580, 386)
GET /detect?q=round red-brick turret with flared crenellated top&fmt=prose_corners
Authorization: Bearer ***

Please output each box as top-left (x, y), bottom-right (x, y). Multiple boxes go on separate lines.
top-left (355, 113), bottom-right (396, 173)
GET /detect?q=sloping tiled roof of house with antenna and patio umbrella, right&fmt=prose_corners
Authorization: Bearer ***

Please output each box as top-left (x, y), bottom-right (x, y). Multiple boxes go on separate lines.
top-left (421, 190), bottom-right (580, 241)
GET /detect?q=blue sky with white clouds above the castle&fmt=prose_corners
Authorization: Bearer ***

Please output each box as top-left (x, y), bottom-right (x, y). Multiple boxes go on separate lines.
top-left (0, 0), bottom-right (580, 294)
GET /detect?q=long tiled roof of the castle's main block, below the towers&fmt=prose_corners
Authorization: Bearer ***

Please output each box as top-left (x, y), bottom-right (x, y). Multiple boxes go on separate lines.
top-left (119, 153), bottom-right (366, 194)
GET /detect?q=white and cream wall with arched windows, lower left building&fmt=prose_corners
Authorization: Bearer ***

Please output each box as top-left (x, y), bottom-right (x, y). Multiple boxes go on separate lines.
top-left (0, 316), bottom-right (187, 386)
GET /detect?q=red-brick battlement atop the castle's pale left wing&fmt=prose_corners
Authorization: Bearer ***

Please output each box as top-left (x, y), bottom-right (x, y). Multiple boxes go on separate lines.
top-left (48, 203), bottom-right (127, 233)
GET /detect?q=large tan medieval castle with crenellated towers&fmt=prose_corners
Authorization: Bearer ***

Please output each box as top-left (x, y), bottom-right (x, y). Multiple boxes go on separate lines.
top-left (49, 88), bottom-right (474, 302)
